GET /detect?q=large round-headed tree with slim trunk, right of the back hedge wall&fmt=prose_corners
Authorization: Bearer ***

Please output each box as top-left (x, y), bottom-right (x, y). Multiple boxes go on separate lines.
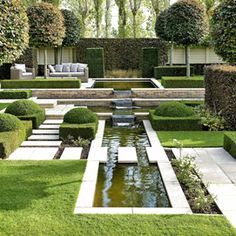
top-left (166, 0), bottom-right (208, 77)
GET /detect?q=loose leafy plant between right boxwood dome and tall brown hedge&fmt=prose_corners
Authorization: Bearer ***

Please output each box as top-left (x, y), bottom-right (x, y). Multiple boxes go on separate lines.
top-left (195, 106), bottom-right (226, 131)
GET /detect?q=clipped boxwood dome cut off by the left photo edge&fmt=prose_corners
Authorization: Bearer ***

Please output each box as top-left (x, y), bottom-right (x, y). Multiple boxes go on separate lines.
top-left (0, 113), bottom-right (23, 132)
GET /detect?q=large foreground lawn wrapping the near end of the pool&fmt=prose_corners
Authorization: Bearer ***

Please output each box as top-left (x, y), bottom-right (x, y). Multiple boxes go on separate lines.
top-left (0, 161), bottom-right (236, 236)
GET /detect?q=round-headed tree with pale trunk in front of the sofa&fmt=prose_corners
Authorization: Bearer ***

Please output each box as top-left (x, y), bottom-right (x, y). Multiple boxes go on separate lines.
top-left (27, 3), bottom-right (65, 78)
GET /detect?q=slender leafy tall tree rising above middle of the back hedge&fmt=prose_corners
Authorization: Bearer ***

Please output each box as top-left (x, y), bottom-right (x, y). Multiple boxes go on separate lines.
top-left (115, 0), bottom-right (127, 38)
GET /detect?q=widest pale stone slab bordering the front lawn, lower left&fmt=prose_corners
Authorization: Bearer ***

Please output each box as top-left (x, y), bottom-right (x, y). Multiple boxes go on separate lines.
top-left (9, 147), bottom-right (58, 160)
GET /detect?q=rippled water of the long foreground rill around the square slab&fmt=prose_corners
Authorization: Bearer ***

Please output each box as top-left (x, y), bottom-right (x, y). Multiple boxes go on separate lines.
top-left (93, 122), bottom-right (171, 208)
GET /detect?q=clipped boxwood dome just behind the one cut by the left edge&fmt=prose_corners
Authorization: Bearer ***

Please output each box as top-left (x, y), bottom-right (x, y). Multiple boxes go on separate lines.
top-left (5, 99), bottom-right (43, 116)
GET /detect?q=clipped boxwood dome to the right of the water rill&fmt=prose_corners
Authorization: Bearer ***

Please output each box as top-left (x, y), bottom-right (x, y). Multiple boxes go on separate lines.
top-left (155, 102), bottom-right (195, 117)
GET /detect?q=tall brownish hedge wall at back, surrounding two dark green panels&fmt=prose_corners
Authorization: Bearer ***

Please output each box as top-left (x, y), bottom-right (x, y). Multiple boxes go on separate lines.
top-left (76, 38), bottom-right (167, 70)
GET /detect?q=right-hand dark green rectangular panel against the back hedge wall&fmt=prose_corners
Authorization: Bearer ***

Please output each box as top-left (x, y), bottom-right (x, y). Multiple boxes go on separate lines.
top-left (140, 47), bottom-right (159, 78)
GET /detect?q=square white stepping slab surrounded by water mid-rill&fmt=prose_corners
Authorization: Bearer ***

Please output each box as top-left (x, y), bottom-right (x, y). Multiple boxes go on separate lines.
top-left (118, 147), bottom-right (138, 163)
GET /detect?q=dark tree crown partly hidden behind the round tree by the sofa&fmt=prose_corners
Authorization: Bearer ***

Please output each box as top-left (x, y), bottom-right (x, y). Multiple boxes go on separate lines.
top-left (61, 9), bottom-right (80, 46)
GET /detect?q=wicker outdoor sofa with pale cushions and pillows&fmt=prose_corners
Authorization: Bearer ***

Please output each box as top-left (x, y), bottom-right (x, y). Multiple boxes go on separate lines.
top-left (47, 63), bottom-right (89, 82)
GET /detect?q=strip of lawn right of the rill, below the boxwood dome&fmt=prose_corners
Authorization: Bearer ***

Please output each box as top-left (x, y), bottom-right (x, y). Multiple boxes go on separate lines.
top-left (157, 131), bottom-right (229, 147)
